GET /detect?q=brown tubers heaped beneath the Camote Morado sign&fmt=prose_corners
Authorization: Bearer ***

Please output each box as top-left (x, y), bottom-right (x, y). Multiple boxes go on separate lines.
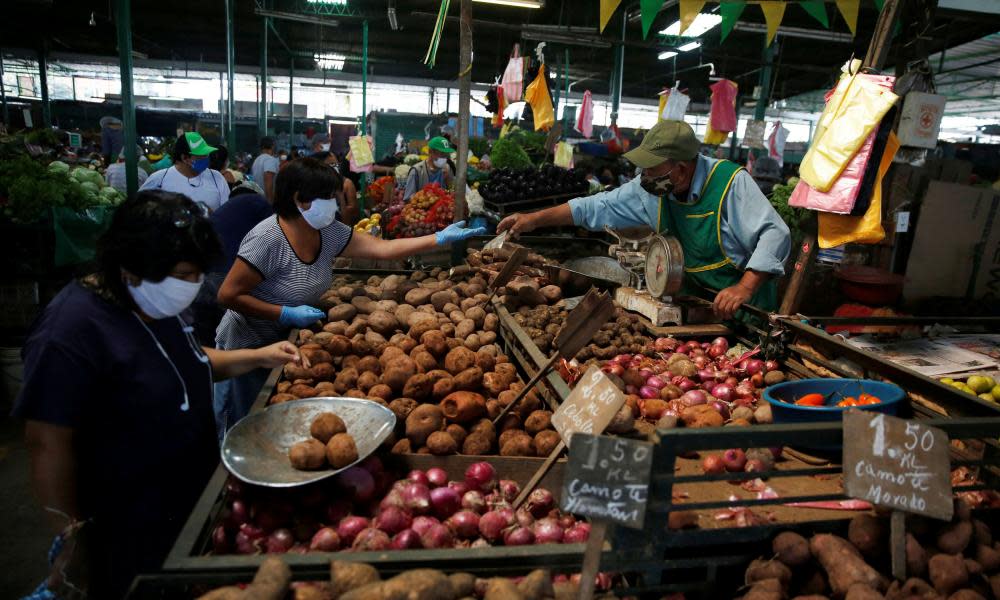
top-left (743, 500), bottom-right (1000, 600)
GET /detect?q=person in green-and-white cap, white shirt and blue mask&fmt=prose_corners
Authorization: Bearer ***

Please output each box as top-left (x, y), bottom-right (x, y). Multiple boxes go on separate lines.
top-left (139, 131), bottom-right (229, 211)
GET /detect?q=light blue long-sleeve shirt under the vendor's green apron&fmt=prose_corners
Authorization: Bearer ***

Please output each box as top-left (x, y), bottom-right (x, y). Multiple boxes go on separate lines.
top-left (569, 155), bottom-right (791, 275)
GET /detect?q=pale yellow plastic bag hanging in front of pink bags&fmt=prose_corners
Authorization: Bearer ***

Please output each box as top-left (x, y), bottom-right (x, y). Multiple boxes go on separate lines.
top-left (799, 68), bottom-right (899, 192)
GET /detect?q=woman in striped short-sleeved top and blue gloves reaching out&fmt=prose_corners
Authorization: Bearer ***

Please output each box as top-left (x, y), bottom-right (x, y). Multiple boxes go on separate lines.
top-left (215, 158), bottom-right (485, 440)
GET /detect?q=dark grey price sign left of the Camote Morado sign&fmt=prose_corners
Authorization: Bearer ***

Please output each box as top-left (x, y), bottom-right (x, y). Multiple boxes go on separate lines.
top-left (560, 433), bottom-right (653, 529)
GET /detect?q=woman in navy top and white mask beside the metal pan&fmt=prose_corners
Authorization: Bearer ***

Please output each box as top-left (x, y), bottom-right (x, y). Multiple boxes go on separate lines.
top-left (13, 191), bottom-right (300, 599)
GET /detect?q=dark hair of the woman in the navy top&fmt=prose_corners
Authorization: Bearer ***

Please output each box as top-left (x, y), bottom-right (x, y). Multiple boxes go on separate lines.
top-left (97, 190), bottom-right (222, 306)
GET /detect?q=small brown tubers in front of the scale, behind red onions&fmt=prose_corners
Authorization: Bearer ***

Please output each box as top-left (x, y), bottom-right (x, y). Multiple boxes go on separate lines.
top-left (514, 305), bottom-right (655, 362)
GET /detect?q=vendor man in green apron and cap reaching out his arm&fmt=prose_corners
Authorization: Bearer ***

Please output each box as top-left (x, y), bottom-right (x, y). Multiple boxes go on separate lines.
top-left (497, 121), bottom-right (791, 319)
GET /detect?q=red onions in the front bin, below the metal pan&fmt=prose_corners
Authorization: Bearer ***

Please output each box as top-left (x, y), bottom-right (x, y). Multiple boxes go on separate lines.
top-left (211, 458), bottom-right (590, 554)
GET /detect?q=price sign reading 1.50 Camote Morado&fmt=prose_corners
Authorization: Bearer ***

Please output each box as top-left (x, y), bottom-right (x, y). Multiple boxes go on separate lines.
top-left (844, 411), bottom-right (953, 521)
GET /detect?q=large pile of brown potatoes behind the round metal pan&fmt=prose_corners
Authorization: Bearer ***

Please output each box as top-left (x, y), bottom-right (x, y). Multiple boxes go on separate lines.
top-left (271, 271), bottom-right (559, 456)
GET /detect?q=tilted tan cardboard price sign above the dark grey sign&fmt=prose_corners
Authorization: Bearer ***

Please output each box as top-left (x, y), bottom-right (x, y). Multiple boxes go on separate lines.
top-left (552, 365), bottom-right (625, 444)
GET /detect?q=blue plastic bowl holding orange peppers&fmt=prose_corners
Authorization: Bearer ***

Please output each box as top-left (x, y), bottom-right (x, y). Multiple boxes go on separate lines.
top-left (764, 379), bottom-right (906, 423)
